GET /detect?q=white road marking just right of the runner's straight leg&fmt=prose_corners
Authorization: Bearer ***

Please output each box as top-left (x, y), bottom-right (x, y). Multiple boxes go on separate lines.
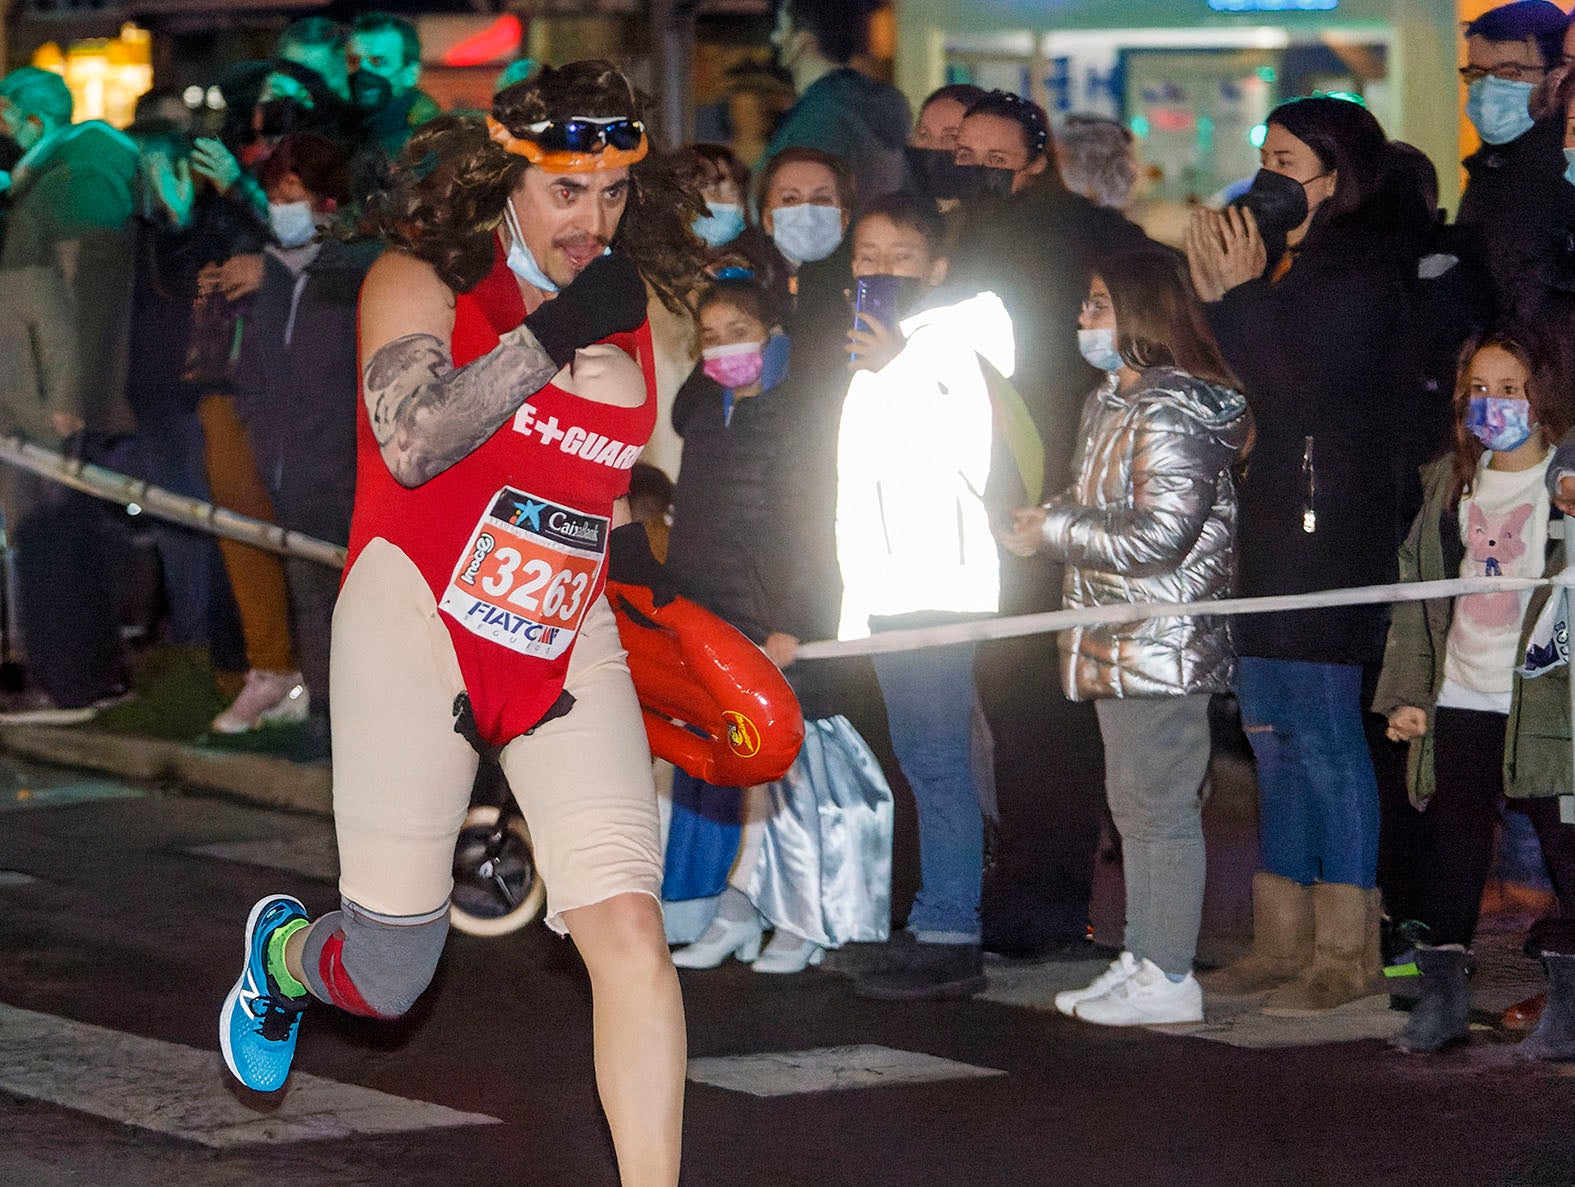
top-left (688, 1044), bottom-right (1005, 1096)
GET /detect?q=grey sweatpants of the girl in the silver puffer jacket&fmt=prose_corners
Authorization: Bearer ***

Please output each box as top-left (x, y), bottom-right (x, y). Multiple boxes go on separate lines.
top-left (1095, 693), bottom-right (1210, 976)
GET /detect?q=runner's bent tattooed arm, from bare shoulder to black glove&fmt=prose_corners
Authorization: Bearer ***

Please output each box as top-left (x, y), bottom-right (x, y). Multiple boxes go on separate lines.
top-left (361, 252), bottom-right (558, 486)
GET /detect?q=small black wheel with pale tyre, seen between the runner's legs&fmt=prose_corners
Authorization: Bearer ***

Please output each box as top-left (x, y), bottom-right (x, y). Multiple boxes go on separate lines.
top-left (449, 804), bottom-right (547, 935)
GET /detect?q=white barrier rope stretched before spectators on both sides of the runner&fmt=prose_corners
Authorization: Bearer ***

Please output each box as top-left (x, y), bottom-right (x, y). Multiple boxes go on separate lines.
top-left (0, 436), bottom-right (1575, 667)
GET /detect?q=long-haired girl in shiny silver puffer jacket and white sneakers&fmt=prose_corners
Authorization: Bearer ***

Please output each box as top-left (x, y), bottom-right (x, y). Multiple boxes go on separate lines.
top-left (1002, 250), bottom-right (1252, 1026)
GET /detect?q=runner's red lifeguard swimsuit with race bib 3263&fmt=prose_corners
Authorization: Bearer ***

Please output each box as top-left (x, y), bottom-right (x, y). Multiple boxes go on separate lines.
top-left (345, 247), bottom-right (657, 746)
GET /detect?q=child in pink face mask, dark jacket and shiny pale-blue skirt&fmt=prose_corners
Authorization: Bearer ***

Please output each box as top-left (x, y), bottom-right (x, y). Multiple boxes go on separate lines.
top-left (663, 279), bottom-right (891, 973)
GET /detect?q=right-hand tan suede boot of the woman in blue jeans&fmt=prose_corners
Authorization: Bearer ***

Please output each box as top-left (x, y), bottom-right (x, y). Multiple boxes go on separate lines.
top-left (1263, 882), bottom-right (1386, 1019)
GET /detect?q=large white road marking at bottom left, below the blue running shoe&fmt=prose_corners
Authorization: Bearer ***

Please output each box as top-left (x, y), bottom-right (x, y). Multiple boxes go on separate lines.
top-left (0, 1004), bottom-right (502, 1149)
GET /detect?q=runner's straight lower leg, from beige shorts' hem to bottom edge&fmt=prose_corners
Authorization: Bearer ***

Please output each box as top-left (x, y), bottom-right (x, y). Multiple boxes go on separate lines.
top-left (564, 893), bottom-right (688, 1187)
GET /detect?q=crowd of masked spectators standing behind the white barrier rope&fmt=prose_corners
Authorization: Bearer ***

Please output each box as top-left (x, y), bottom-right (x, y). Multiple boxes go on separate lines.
top-left (0, 0), bottom-right (1575, 1058)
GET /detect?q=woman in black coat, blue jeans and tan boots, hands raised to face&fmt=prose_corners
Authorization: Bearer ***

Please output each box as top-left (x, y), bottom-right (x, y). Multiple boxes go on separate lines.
top-left (1188, 98), bottom-right (1429, 1014)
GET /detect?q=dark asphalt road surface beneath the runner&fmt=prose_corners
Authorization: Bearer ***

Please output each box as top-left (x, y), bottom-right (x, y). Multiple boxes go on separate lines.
top-left (0, 759), bottom-right (1575, 1187)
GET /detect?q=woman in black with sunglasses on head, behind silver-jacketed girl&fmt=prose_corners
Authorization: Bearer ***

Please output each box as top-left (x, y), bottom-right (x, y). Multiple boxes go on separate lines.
top-left (951, 91), bottom-right (1154, 959)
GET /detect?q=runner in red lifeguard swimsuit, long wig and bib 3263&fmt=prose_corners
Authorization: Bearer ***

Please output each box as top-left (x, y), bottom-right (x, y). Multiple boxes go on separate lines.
top-left (221, 61), bottom-right (702, 1184)
